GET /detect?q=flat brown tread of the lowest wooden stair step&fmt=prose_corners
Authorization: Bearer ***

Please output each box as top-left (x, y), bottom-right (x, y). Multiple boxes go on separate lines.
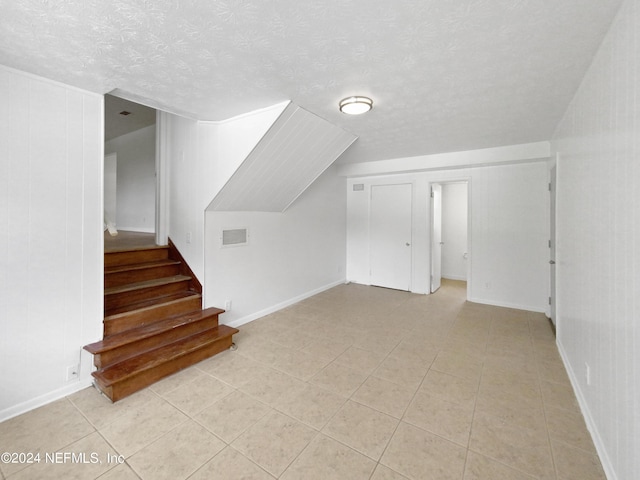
top-left (92, 325), bottom-right (239, 387)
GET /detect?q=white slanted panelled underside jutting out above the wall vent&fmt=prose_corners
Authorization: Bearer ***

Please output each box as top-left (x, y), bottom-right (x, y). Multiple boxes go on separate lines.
top-left (208, 103), bottom-right (356, 212)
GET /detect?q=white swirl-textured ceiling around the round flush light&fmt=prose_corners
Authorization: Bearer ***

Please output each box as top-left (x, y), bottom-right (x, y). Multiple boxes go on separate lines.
top-left (0, 0), bottom-right (621, 161)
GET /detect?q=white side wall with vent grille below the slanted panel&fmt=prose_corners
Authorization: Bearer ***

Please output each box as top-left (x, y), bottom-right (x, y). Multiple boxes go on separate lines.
top-left (205, 167), bottom-right (346, 326)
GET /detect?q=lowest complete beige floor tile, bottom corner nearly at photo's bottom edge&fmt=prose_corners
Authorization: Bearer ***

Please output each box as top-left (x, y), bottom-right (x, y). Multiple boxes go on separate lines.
top-left (231, 412), bottom-right (317, 477)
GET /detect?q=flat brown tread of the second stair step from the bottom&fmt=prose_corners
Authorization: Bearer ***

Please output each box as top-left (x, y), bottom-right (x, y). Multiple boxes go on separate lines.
top-left (84, 307), bottom-right (224, 355)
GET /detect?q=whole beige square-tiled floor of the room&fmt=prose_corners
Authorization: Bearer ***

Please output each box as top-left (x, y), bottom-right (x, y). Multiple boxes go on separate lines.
top-left (0, 281), bottom-right (605, 480)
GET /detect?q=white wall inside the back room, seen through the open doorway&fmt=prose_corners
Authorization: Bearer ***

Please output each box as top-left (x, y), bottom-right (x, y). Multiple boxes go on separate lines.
top-left (442, 183), bottom-right (468, 280)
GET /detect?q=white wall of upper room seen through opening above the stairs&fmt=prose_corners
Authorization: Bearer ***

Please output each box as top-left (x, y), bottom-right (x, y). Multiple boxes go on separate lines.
top-left (104, 125), bottom-right (156, 233)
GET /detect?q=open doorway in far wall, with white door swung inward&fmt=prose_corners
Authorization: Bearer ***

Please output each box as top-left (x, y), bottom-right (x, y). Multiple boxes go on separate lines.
top-left (430, 180), bottom-right (470, 293)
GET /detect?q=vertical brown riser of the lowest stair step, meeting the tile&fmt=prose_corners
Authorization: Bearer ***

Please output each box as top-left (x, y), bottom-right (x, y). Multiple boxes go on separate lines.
top-left (96, 336), bottom-right (232, 402)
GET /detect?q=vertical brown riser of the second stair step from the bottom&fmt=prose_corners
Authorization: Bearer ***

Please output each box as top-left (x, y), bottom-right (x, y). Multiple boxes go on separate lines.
top-left (93, 315), bottom-right (218, 369)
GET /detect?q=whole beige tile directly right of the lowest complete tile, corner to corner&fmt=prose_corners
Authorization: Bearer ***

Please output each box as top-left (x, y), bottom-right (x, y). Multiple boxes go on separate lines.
top-left (322, 401), bottom-right (399, 461)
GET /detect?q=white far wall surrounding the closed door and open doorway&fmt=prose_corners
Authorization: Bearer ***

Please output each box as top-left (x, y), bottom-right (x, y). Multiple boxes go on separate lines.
top-left (347, 162), bottom-right (549, 312)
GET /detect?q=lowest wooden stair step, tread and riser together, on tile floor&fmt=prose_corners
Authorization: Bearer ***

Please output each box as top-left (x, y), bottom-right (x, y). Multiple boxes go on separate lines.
top-left (92, 325), bottom-right (239, 402)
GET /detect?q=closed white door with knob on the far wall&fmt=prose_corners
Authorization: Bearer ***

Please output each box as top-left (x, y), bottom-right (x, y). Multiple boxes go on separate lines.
top-left (369, 184), bottom-right (413, 291)
